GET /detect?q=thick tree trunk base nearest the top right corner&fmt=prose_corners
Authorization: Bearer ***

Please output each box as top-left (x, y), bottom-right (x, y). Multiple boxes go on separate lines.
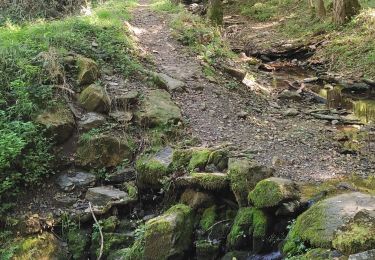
top-left (333, 0), bottom-right (361, 24)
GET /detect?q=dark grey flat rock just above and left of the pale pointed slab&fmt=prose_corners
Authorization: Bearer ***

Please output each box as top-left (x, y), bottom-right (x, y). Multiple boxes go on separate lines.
top-left (56, 172), bottom-right (96, 192)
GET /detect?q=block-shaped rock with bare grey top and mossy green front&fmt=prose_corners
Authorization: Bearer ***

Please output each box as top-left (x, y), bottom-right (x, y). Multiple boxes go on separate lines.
top-left (136, 147), bottom-right (173, 188)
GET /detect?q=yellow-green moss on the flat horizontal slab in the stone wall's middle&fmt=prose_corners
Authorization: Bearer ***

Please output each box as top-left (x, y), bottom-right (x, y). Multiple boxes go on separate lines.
top-left (189, 173), bottom-right (228, 190)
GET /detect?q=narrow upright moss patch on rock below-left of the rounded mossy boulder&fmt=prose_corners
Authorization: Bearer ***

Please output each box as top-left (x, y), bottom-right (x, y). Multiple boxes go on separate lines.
top-left (227, 207), bottom-right (253, 249)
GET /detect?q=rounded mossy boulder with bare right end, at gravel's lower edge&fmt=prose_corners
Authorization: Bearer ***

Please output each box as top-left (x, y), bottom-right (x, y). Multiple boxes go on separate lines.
top-left (248, 177), bottom-right (300, 208)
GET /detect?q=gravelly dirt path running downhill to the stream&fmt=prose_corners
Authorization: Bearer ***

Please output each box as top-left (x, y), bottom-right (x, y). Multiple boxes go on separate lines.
top-left (131, 0), bottom-right (374, 181)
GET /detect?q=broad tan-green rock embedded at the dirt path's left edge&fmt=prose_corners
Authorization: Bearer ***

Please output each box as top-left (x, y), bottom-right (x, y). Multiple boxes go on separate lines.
top-left (137, 90), bottom-right (182, 127)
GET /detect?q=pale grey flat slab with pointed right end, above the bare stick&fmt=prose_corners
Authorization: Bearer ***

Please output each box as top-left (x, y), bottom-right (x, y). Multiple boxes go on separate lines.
top-left (85, 186), bottom-right (136, 207)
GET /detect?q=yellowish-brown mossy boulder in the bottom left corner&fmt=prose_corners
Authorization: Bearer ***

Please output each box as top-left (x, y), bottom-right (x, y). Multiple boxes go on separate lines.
top-left (12, 232), bottom-right (68, 260)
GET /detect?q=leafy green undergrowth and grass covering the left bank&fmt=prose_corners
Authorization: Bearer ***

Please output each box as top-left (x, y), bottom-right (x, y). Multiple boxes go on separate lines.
top-left (0, 0), bottom-right (142, 216)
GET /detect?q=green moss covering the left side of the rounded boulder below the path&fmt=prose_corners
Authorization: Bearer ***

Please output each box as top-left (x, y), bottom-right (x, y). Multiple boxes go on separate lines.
top-left (248, 180), bottom-right (283, 207)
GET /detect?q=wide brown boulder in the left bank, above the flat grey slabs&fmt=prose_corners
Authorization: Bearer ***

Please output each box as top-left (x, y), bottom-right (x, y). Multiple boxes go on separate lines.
top-left (76, 133), bottom-right (135, 168)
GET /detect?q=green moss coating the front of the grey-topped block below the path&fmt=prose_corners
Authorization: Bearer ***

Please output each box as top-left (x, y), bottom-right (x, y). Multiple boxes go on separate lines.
top-left (135, 155), bottom-right (170, 187)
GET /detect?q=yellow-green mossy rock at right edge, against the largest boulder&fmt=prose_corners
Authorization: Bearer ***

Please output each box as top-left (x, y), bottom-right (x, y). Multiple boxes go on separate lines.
top-left (332, 210), bottom-right (375, 255)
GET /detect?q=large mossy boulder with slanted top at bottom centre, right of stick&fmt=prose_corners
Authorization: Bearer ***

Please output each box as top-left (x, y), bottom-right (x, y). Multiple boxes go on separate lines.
top-left (144, 204), bottom-right (193, 260)
